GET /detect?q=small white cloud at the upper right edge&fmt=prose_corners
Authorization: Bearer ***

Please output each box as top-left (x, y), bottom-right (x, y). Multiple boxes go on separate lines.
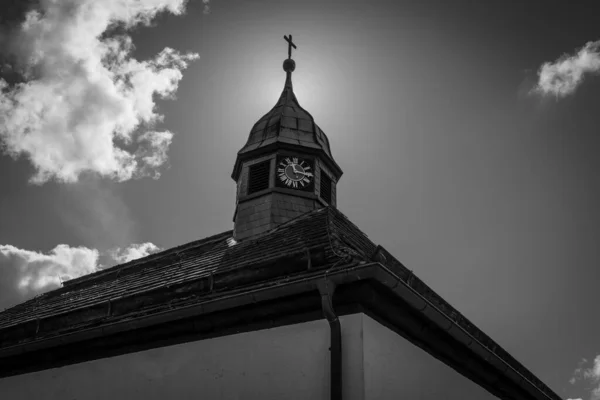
top-left (534, 40), bottom-right (600, 97)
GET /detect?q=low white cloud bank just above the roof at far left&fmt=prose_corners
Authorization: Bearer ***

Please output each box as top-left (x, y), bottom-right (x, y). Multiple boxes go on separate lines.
top-left (0, 243), bottom-right (160, 311)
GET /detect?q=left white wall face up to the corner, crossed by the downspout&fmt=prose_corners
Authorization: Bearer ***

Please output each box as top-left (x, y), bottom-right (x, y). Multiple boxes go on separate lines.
top-left (0, 315), bottom-right (363, 400)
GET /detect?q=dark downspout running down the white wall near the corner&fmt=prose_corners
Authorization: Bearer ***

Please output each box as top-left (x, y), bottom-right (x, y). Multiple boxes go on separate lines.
top-left (317, 280), bottom-right (342, 400)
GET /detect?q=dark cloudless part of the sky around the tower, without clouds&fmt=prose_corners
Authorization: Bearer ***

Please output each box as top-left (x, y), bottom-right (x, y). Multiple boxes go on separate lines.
top-left (0, 0), bottom-right (600, 399)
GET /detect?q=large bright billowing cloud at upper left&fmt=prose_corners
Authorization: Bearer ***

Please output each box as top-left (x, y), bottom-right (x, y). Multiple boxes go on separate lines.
top-left (0, 0), bottom-right (198, 184)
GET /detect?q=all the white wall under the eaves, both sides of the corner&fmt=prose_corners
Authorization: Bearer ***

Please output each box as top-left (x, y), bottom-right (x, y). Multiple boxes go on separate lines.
top-left (0, 314), bottom-right (504, 400)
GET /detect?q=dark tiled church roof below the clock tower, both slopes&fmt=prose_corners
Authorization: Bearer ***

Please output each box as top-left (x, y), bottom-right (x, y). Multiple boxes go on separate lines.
top-left (0, 207), bottom-right (559, 399)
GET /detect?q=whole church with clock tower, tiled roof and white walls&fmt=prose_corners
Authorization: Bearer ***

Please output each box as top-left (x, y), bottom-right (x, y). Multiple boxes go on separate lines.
top-left (0, 35), bottom-right (560, 400)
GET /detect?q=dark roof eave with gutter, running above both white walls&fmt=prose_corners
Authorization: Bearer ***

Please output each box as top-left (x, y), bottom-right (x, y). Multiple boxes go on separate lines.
top-left (0, 262), bottom-right (560, 400)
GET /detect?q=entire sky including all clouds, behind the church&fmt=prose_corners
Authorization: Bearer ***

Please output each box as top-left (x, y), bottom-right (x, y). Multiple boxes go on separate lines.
top-left (0, 0), bottom-right (600, 400)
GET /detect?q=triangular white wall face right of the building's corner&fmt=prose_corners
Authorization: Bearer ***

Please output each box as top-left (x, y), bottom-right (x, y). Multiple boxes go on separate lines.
top-left (363, 316), bottom-right (497, 400)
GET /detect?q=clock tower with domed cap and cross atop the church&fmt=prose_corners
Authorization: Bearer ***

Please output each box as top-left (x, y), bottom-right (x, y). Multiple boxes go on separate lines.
top-left (231, 35), bottom-right (342, 241)
